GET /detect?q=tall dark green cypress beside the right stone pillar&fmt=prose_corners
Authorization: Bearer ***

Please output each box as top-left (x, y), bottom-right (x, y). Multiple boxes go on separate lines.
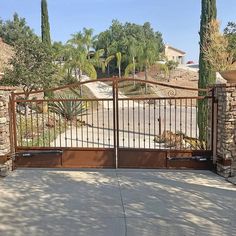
top-left (198, 0), bottom-right (217, 141)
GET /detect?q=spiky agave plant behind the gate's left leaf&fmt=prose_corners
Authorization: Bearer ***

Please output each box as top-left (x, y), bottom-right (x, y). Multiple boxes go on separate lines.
top-left (49, 93), bottom-right (87, 121)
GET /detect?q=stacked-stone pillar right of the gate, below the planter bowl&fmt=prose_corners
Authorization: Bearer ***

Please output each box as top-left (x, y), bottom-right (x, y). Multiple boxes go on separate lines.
top-left (215, 84), bottom-right (236, 177)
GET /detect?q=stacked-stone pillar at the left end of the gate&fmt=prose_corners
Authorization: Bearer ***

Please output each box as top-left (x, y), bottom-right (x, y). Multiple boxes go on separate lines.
top-left (0, 92), bottom-right (12, 176)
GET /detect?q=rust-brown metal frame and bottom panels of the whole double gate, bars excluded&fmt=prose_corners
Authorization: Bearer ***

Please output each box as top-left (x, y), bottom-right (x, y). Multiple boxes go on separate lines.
top-left (10, 77), bottom-right (214, 169)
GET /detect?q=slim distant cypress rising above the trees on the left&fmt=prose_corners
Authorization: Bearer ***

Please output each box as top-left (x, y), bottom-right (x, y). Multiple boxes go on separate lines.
top-left (41, 0), bottom-right (51, 46)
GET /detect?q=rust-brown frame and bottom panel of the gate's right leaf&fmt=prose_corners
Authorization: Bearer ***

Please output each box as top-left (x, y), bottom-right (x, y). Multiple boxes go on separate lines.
top-left (113, 78), bottom-right (216, 169)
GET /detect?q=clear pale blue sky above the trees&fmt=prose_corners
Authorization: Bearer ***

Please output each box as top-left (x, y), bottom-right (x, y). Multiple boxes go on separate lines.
top-left (0, 0), bottom-right (236, 62)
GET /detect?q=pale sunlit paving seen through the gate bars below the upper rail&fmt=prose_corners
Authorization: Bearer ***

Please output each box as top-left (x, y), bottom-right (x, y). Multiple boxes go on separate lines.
top-left (51, 102), bottom-right (198, 149)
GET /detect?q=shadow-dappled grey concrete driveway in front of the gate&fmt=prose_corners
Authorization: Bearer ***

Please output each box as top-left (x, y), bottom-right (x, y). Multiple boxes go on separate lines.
top-left (0, 169), bottom-right (236, 236)
